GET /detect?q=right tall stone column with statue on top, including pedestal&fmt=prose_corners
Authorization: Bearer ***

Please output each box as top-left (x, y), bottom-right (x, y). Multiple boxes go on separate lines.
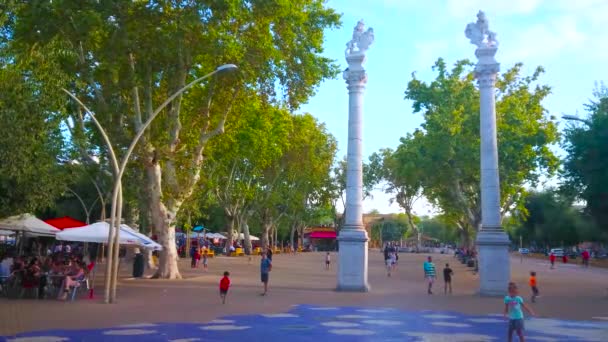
top-left (465, 11), bottom-right (511, 296)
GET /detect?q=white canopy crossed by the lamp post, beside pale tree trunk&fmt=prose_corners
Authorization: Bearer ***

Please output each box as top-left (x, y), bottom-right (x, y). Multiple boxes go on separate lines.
top-left (56, 222), bottom-right (162, 250)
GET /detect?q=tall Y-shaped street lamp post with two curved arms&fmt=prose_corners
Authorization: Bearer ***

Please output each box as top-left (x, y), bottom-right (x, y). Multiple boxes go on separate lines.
top-left (63, 64), bottom-right (237, 303)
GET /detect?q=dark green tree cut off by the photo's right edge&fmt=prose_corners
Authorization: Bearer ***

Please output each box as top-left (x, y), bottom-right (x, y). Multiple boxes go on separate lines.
top-left (561, 84), bottom-right (608, 232)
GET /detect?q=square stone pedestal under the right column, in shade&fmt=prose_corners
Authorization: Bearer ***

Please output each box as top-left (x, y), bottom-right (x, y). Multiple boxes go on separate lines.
top-left (476, 227), bottom-right (511, 296)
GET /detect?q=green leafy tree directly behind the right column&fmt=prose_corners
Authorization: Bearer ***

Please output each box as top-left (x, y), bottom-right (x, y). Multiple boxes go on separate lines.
top-left (405, 59), bottom-right (558, 245)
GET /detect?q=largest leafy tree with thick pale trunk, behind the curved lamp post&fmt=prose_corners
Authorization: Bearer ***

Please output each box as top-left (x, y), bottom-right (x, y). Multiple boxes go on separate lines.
top-left (4, 0), bottom-right (339, 278)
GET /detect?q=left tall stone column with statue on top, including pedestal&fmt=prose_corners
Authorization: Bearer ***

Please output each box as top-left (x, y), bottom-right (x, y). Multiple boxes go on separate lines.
top-left (337, 20), bottom-right (374, 292)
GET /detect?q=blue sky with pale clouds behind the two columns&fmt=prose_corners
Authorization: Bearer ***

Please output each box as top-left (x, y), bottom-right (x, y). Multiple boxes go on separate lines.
top-left (301, 0), bottom-right (608, 215)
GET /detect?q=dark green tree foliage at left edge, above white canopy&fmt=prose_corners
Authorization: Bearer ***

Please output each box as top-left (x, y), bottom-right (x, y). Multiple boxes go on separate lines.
top-left (0, 63), bottom-right (67, 217)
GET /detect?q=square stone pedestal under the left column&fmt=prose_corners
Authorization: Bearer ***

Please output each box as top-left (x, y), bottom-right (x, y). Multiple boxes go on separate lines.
top-left (336, 226), bottom-right (370, 292)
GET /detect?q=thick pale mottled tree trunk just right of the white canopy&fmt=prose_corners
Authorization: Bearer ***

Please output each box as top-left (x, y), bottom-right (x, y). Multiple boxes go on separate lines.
top-left (146, 161), bottom-right (182, 279)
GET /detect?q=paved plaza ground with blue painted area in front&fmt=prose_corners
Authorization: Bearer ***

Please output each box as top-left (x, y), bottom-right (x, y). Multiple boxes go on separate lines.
top-left (0, 250), bottom-right (608, 341)
